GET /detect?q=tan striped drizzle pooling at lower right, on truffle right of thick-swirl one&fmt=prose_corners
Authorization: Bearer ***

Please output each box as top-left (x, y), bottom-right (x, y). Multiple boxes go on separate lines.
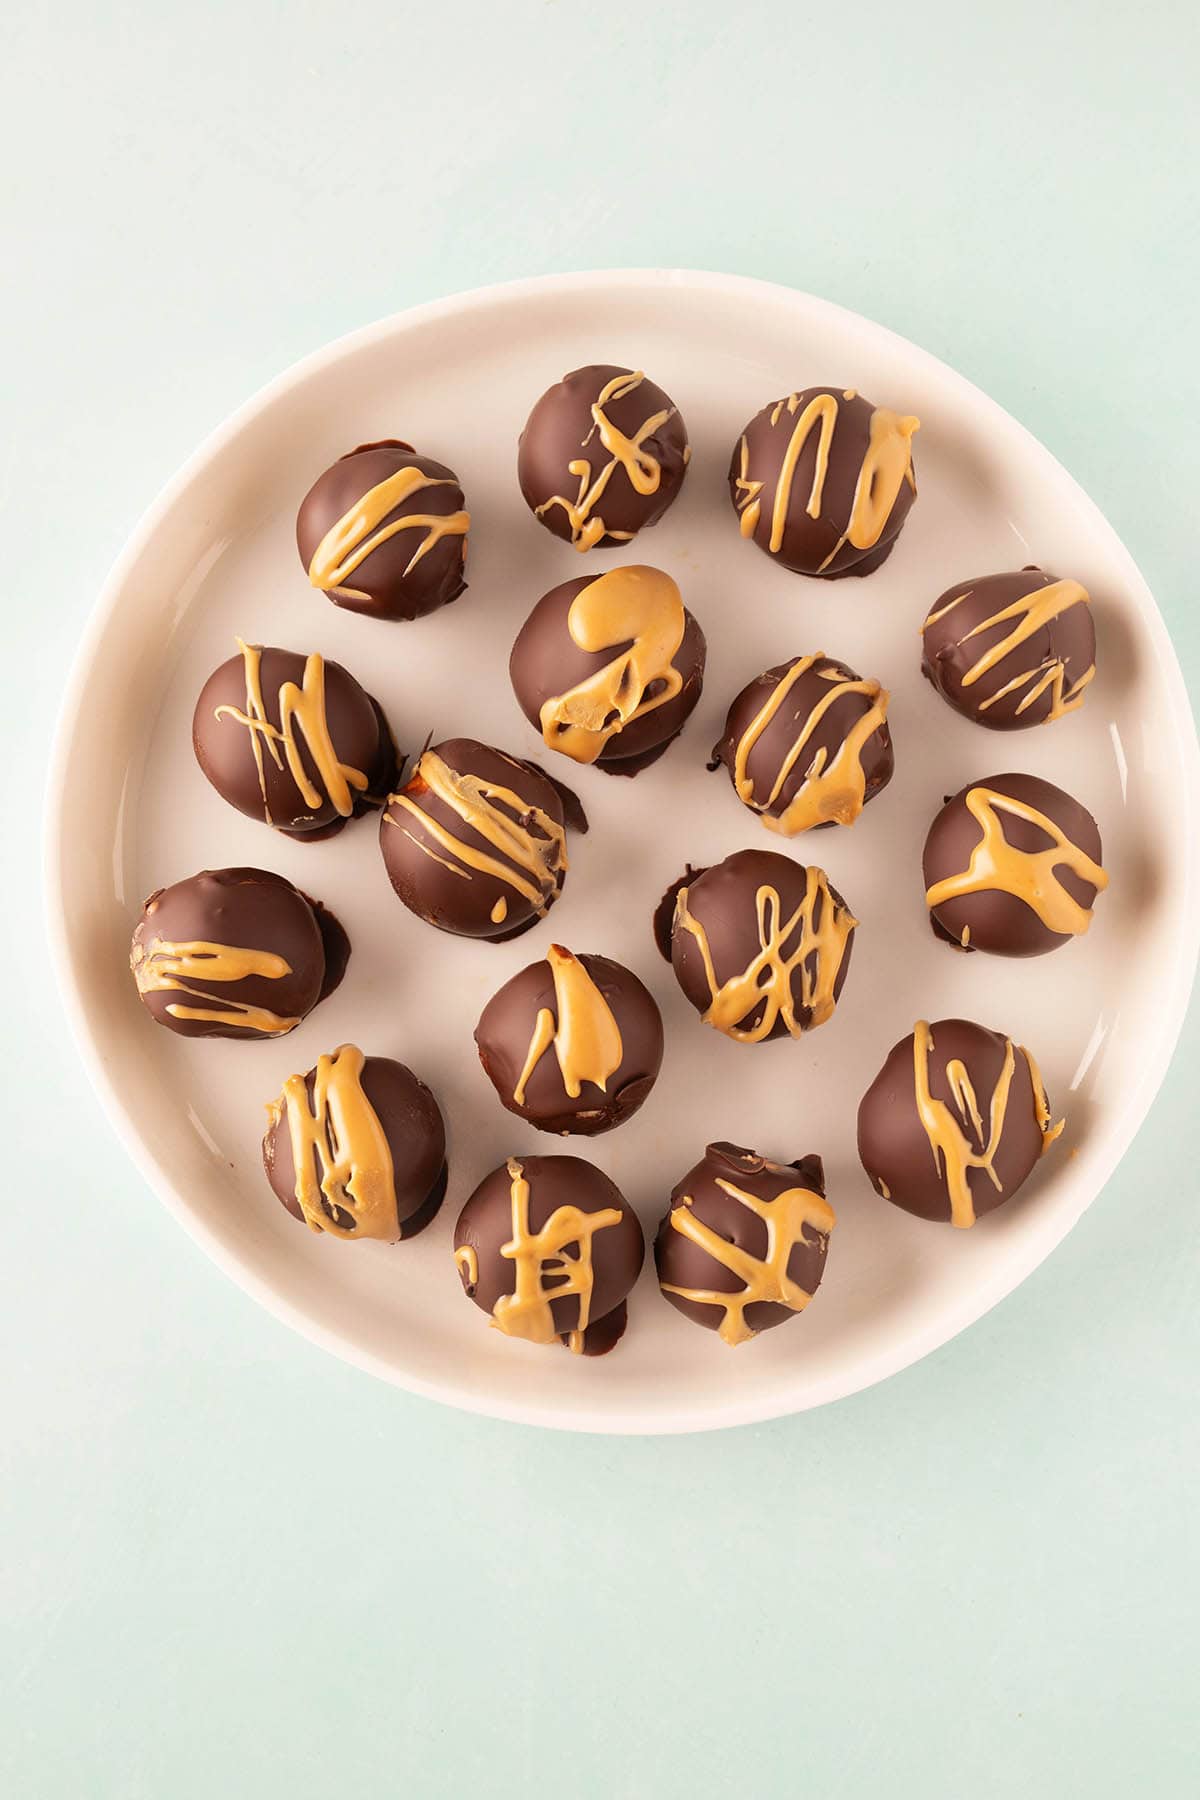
top-left (734, 650), bottom-right (889, 837)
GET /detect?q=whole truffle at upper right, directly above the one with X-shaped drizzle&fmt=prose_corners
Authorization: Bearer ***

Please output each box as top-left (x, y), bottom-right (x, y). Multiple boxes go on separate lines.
top-left (921, 567), bottom-right (1096, 731)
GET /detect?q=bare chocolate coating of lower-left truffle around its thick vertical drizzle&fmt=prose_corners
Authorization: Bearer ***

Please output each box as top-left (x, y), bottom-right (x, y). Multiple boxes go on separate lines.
top-left (263, 1057), bottom-right (446, 1240)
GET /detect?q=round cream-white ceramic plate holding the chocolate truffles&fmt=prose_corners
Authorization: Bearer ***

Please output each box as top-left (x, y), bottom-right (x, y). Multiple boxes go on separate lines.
top-left (49, 270), bottom-right (1200, 1431)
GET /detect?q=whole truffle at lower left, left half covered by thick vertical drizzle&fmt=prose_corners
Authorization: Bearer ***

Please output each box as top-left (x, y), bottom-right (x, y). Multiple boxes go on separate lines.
top-left (263, 1044), bottom-right (446, 1244)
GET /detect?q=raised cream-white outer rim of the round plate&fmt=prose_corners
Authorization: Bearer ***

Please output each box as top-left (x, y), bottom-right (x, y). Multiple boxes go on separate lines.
top-left (43, 268), bottom-right (1200, 1436)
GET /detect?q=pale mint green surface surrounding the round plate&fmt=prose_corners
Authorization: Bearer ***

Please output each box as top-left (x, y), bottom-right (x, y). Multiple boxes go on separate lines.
top-left (0, 0), bottom-right (1200, 1800)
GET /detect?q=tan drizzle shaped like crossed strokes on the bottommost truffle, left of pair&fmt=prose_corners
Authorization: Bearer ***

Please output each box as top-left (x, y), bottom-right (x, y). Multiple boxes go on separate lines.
top-left (491, 1156), bottom-right (621, 1355)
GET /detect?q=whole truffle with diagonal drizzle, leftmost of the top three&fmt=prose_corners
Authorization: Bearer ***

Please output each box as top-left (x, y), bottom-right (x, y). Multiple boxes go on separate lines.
top-left (295, 437), bottom-right (471, 619)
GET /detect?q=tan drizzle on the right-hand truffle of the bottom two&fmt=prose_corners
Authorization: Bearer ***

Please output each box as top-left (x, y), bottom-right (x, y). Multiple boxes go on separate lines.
top-left (662, 1175), bottom-right (835, 1345)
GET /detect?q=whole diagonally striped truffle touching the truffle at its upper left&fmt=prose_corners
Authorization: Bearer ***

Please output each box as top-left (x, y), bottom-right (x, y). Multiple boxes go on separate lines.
top-left (380, 738), bottom-right (587, 941)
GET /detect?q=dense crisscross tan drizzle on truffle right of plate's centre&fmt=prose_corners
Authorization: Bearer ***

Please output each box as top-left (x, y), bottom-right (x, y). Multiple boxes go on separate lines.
top-left (675, 868), bottom-right (858, 1044)
